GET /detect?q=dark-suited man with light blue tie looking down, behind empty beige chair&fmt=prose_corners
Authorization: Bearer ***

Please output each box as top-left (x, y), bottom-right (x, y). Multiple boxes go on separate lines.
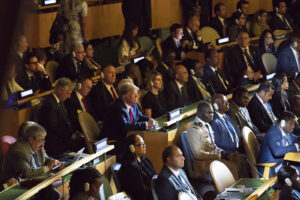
top-left (248, 82), bottom-right (277, 133)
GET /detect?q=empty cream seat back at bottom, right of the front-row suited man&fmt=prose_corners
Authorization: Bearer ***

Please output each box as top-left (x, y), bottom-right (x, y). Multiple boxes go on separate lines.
top-left (209, 160), bottom-right (235, 193)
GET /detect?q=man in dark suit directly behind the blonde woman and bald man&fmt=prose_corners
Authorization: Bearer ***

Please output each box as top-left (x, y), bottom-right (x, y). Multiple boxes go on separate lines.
top-left (156, 49), bottom-right (176, 86)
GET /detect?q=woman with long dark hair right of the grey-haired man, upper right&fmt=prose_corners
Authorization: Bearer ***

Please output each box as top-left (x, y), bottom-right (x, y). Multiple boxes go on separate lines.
top-left (258, 29), bottom-right (276, 56)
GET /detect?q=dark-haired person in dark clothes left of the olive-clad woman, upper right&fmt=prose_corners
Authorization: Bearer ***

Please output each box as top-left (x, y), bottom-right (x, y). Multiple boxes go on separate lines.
top-left (227, 12), bottom-right (248, 41)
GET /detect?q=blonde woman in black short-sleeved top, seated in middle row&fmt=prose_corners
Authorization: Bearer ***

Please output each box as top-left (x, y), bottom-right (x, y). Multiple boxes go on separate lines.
top-left (142, 71), bottom-right (167, 118)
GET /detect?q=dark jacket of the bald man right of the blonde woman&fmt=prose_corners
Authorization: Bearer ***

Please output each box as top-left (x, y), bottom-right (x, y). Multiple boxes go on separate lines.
top-left (164, 80), bottom-right (191, 111)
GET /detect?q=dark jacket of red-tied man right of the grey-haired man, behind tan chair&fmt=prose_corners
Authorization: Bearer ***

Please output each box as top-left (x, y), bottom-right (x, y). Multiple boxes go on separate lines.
top-left (64, 90), bottom-right (95, 131)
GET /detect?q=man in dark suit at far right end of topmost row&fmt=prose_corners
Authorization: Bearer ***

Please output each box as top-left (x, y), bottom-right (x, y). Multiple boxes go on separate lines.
top-left (269, 0), bottom-right (293, 31)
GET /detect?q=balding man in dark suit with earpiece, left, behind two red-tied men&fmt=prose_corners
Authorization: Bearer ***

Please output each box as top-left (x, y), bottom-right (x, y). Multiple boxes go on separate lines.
top-left (56, 43), bottom-right (88, 81)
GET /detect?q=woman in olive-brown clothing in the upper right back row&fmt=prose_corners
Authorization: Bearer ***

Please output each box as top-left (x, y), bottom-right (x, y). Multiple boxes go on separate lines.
top-left (250, 9), bottom-right (270, 36)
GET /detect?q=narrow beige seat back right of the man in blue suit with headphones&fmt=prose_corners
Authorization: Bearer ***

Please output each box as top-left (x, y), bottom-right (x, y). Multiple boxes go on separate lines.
top-left (242, 126), bottom-right (260, 178)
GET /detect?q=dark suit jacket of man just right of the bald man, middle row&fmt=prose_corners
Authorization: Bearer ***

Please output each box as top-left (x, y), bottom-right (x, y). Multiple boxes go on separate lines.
top-left (203, 64), bottom-right (231, 94)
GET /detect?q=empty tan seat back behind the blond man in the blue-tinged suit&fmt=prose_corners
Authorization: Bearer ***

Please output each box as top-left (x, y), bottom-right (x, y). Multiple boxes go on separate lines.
top-left (78, 112), bottom-right (100, 153)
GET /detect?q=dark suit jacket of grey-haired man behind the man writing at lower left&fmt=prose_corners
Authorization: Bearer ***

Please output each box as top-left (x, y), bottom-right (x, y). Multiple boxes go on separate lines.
top-left (38, 94), bottom-right (74, 156)
